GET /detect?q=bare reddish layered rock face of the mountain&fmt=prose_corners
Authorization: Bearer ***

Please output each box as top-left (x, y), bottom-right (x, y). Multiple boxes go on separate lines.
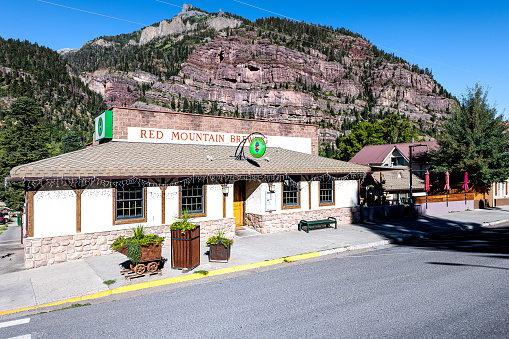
top-left (140, 37), bottom-right (454, 124)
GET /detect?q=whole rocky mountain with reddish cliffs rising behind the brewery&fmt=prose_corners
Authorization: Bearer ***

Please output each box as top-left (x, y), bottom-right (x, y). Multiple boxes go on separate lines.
top-left (64, 5), bottom-right (455, 146)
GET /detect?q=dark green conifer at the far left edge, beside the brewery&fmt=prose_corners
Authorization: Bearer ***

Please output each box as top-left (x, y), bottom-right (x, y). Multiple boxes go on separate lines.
top-left (0, 98), bottom-right (50, 210)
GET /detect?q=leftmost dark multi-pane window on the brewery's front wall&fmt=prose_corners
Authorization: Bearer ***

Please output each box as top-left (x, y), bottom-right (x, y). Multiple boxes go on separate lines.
top-left (114, 186), bottom-right (146, 224)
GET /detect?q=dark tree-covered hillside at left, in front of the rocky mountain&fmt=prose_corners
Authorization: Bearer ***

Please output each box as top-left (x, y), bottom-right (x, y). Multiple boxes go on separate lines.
top-left (0, 37), bottom-right (106, 147)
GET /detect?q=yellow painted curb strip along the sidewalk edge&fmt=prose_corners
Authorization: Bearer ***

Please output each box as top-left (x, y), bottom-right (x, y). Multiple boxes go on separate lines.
top-left (0, 252), bottom-right (320, 315)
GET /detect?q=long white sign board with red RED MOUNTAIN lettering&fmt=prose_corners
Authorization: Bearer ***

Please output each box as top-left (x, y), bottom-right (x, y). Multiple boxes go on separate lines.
top-left (127, 127), bottom-right (311, 154)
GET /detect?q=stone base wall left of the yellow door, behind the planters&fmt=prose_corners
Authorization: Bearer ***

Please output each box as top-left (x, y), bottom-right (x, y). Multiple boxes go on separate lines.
top-left (24, 218), bottom-right (235, 269)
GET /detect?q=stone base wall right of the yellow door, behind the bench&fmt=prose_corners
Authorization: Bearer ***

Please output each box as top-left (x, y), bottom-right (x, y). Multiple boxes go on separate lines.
top-left (244, 207), bottom-right (360, 234)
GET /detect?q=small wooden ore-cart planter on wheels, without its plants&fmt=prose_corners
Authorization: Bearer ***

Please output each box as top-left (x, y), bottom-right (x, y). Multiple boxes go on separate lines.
top-left (118, 243), bottom-right (162, 280)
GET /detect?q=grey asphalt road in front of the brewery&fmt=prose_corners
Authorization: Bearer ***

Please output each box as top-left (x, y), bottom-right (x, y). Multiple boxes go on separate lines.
top-left (0, 227), bottom-right (509, 338)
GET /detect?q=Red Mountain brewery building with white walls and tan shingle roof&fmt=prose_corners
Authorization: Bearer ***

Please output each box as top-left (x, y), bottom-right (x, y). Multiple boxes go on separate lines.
top-left (8, 107), bottom-right (370, 268)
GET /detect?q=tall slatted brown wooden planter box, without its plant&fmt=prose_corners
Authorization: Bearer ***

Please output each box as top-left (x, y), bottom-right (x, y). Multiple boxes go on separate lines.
top-left (171, 226), bottom-right (200, 270)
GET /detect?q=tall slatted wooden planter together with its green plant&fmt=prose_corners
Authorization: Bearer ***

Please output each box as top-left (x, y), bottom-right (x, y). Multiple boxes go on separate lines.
top-left (170, 211), bottom-right (200, 270)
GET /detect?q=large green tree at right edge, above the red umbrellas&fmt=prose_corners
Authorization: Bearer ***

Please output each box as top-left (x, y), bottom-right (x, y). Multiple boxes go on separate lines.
top-left (432, 84), bottom-right (509, 185)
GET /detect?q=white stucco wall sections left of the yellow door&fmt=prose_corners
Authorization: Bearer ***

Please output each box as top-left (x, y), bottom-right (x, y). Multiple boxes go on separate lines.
top-left (34, 184), bottom-right (233, 238)
